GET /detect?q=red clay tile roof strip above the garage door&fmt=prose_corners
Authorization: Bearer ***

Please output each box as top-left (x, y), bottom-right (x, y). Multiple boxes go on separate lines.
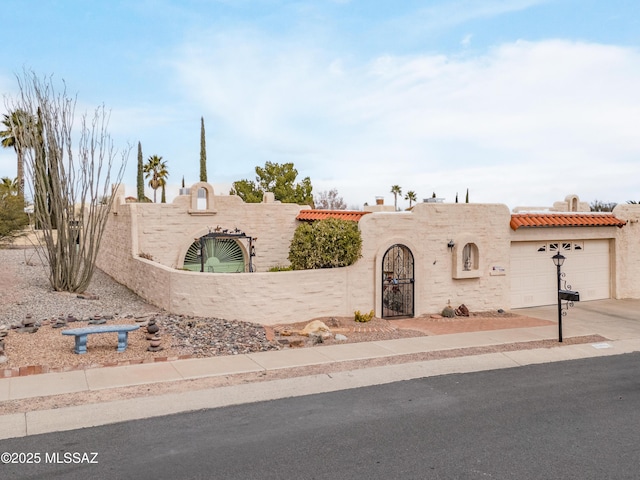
top-left (510, 213), bottom-right (627, 230)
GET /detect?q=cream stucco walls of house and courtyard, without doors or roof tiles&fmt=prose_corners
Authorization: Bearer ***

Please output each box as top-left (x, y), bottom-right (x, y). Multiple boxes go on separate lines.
top-left (98, 186), bottom-right (640, 324)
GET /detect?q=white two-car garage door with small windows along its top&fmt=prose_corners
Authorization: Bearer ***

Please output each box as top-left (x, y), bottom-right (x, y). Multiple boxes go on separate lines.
top-left (510, 240), bottom-right (611, 308)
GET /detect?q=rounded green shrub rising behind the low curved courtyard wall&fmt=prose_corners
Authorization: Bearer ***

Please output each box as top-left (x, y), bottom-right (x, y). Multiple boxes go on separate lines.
top-left (289, 218), bottom-right (362, 270)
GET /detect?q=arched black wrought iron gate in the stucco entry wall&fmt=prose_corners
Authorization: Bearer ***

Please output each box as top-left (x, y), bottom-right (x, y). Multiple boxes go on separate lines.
top-left (382, 244), bottom-right (414, 318)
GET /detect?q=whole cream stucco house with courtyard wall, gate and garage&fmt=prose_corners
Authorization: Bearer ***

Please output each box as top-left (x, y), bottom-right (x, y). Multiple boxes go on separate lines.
top-left (98, 182), bottom-right (640, 325)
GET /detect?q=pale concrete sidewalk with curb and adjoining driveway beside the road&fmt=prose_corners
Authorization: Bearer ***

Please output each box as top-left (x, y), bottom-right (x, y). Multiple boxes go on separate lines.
top-left (0, 300), bottom-right (640, 438)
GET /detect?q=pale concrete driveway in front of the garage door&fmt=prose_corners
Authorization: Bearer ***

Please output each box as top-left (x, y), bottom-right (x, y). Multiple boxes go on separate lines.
top-left (513, 299), bottom-right (640, 340)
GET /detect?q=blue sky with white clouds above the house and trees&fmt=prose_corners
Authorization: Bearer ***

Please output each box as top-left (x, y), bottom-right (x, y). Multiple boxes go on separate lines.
top-left (0, 0), bottom-right (640, 208)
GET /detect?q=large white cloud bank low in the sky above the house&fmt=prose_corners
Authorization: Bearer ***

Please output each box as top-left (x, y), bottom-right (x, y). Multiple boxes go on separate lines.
top-left (170, 33), bottom-right (640, 207)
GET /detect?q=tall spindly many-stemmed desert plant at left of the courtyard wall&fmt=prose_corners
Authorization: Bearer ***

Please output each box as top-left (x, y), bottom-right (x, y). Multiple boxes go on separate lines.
top-left (5, 71), bottom-right (130, 292)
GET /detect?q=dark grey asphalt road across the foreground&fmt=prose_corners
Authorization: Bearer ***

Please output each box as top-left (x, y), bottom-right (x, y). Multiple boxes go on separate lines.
top-left (0, 354), bottom-right (640, 480)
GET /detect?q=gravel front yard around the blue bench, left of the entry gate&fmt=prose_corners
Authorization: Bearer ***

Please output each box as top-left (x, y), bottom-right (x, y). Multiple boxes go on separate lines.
top-left (0, 249), bottom-right (425, 371)
